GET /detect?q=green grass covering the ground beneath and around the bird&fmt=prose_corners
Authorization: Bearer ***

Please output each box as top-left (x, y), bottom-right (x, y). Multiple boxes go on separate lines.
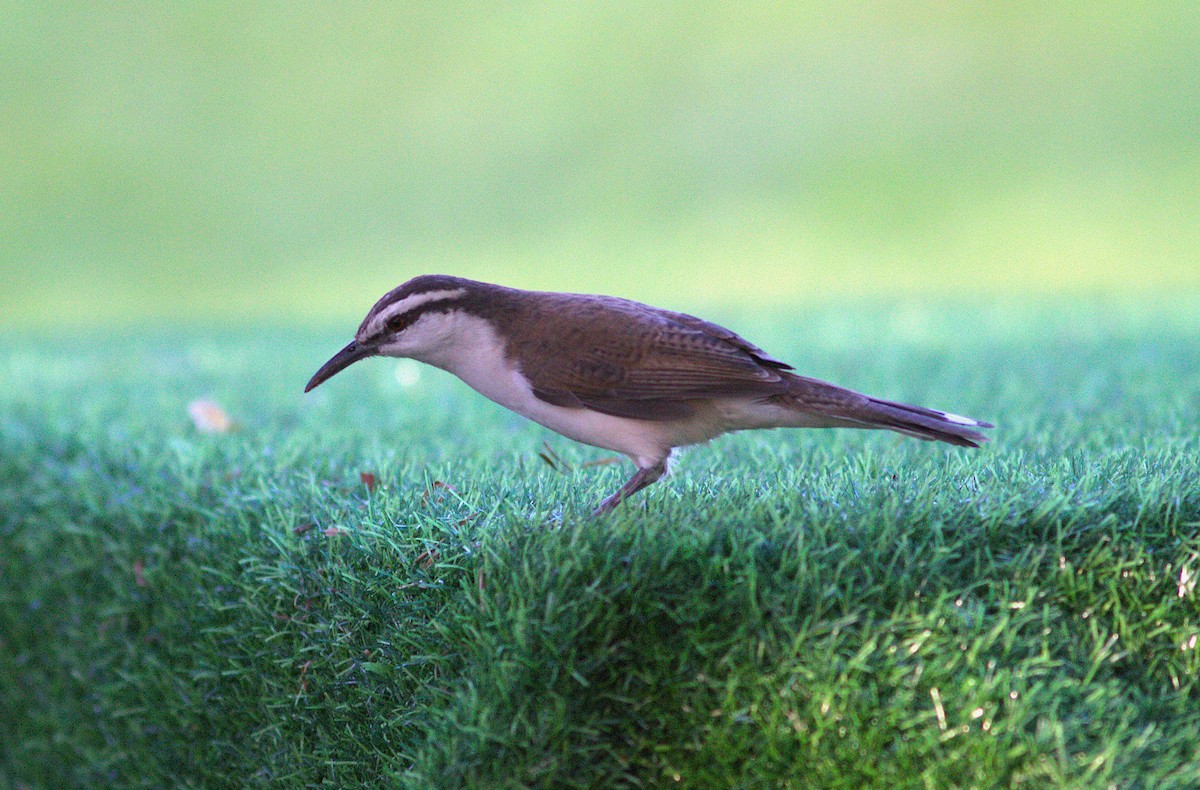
top-left (7, 298), bottom-right (1200, 788)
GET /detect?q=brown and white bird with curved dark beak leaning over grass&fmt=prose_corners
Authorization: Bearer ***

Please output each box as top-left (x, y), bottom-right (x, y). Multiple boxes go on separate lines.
top-left (305, 274), bottom-right (992, 515)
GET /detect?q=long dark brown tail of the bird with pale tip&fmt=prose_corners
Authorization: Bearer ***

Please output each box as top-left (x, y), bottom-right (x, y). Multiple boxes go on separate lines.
top-left (779, 375), bottom-right (991, 447)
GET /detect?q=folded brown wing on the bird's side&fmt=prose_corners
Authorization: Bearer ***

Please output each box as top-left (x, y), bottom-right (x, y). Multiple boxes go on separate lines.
top-left (510, 297), bottom-right (788, 420)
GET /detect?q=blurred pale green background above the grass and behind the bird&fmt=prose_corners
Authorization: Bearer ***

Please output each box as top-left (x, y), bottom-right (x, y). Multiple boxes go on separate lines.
top-left (0, 1), bottom-right (1200, 328)
